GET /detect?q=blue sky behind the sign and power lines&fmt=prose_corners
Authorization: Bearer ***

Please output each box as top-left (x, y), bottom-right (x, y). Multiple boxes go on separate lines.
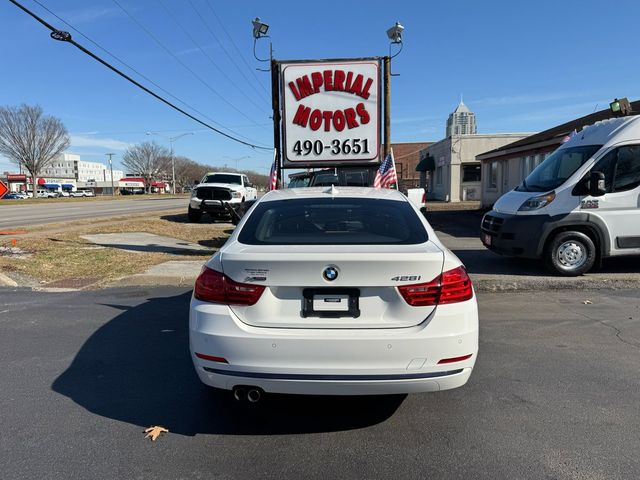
top-left (0, 0), bottom-right (640, 173)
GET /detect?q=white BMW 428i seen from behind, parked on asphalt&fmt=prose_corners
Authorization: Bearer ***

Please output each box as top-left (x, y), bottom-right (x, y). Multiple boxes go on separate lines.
top-left (189, 187), bottom-right (478, 401)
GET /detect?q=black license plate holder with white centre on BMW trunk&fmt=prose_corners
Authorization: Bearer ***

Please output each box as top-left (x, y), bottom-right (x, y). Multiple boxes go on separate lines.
top-left (300, 288), bottom-right (360, 318)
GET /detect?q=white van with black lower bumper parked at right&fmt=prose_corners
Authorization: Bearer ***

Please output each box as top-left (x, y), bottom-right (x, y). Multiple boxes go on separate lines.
top-left (481, 116), bottom-right (640, 276)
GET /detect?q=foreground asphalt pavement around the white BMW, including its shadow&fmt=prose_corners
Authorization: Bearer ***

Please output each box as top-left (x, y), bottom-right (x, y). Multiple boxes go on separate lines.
top-left (0, 288), bottom-right (640, 480)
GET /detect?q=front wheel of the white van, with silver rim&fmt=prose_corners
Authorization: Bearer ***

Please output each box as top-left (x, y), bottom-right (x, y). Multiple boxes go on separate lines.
top-left (545, 232), bottom-right (596, 277)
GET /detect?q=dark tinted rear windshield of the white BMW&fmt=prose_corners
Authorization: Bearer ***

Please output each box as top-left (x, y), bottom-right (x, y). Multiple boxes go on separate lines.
top-left (238, 198), bottom-right (428, 245)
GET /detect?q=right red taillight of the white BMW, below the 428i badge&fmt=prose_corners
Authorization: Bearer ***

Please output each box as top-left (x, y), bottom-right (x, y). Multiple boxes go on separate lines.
top-left (398, 265), bottom-right (473, 307)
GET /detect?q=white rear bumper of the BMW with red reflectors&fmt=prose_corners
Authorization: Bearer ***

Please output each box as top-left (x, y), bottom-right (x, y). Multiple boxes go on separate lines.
top-left (189, 297), bottom-right (478, 395)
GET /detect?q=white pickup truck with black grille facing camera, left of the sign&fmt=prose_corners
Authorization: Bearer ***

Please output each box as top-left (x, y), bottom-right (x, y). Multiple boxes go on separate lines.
top-left (188, 172), bottom-right (258, 222)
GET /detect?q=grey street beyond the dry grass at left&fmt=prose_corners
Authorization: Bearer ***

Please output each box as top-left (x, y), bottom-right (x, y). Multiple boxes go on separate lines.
top-left (0, 197), bottom-right (188, 229)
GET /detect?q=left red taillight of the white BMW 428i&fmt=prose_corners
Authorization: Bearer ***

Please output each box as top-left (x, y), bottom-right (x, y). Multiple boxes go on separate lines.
top-left (193, 267), bottom-right (264, 305)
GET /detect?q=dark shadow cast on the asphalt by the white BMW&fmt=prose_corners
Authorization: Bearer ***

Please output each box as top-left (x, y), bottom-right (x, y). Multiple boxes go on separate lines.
top-left (52, 292), bottom-right (406, 435)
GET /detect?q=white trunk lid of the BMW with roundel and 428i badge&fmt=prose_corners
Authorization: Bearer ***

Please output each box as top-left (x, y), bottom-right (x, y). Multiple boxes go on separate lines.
top-left (218, 241), bottom-right (444, 329)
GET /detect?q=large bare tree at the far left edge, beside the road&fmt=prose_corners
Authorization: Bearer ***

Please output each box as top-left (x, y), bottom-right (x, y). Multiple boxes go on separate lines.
top-left (0, 104), bottom-right (69, 198)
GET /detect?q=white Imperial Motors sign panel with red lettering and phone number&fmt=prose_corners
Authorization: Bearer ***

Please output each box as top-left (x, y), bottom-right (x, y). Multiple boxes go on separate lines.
top-left (280, 59), bottom-right (380, 167)
